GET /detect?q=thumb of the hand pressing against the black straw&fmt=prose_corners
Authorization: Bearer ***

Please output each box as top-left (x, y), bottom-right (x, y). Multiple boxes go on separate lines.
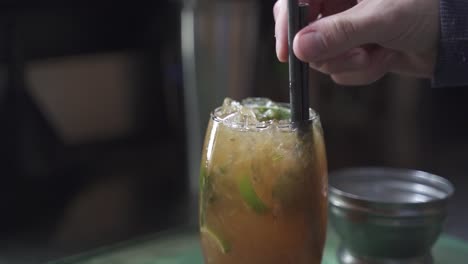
top-left (293, 1), bottom-right (382, 62)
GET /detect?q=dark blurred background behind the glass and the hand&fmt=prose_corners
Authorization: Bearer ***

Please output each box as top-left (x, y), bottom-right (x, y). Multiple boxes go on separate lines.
top-left (0, 0), bottom-right (468, 263)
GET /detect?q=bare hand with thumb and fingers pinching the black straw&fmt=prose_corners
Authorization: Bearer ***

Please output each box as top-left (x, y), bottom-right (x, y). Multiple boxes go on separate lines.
top-left (273, 0), bottom-right (440, 85)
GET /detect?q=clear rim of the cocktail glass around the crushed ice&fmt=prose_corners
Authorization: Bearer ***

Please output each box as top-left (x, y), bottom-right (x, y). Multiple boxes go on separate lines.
top-left (210, 102), bottom-right (320, 130)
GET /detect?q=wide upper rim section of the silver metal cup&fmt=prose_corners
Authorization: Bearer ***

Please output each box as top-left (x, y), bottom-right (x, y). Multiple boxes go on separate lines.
top-left (329, 167), bottom-right (454, 217)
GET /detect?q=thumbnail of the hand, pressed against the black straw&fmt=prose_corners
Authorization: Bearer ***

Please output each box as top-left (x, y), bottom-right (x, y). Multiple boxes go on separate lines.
top-left (298, 32), bottom-right (325, 61)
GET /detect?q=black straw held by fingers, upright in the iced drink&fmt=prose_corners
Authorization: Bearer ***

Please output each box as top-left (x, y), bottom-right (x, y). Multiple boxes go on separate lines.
top-left (288, 0), bottom-right (309, 123)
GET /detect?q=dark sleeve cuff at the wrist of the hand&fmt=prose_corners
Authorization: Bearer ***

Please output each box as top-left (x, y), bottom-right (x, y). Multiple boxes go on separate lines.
top-left (433, 0), bottom-right (468, 87)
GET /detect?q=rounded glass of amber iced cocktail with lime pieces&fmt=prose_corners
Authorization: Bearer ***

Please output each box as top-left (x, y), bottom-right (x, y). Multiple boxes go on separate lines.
top-left (200, 99), bottom-right (327, 264)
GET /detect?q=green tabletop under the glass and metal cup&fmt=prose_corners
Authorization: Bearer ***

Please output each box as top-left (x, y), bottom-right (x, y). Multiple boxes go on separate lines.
top-left (49, 225), bottom-right (468, 264)
